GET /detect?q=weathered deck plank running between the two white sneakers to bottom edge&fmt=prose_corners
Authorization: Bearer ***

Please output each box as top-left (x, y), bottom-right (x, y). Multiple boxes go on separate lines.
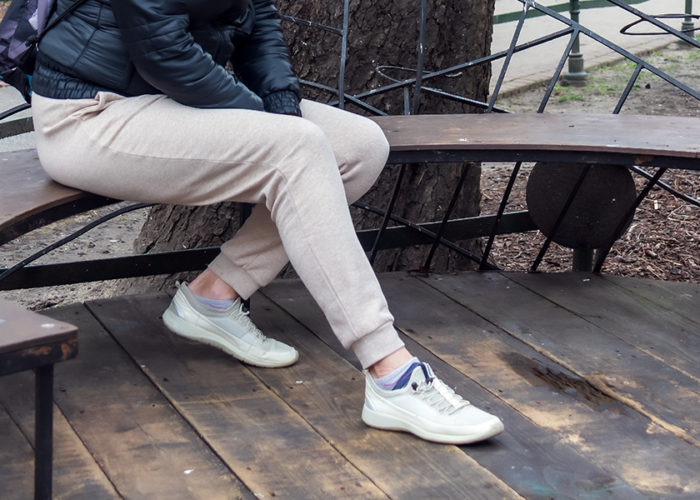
top-left (246, 295), bottom-right (518, 499)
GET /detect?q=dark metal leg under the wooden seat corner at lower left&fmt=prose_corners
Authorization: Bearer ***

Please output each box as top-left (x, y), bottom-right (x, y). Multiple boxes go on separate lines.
top-left (34, 365), bottom-right (53, 500)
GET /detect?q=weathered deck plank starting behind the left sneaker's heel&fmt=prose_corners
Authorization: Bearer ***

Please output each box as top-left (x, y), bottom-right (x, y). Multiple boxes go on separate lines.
top-left (90, 295), bottom-right (386, 499)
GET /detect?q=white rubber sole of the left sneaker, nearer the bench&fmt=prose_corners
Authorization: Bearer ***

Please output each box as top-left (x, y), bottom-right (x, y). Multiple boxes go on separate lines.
top-left (163, 308), bottom-right (299, 368)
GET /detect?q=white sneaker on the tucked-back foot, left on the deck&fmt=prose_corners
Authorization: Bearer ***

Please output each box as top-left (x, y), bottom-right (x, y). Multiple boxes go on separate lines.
top-left (163, 283), bottom-right (299, 368)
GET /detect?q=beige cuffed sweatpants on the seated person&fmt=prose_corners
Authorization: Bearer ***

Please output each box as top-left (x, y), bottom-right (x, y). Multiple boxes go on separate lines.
top-left (32, 93), bottom-right (403, 367)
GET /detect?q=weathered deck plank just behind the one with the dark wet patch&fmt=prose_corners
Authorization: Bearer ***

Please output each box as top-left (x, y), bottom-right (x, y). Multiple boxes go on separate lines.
top-left (418, 273), bottom-right (700, 447)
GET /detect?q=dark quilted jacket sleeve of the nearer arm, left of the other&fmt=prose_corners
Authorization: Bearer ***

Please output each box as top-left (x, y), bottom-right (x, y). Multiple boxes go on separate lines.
top-left (112, 0), bottom-right (263, 110)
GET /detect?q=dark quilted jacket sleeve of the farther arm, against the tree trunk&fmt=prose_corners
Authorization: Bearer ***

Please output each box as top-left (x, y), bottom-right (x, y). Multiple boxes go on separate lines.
top-left (231, 0), bottom-right (299, 104)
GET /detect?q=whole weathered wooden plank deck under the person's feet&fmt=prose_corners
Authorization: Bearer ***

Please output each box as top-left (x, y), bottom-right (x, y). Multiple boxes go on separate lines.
top-left (0, 273), bottom-right (700, 499)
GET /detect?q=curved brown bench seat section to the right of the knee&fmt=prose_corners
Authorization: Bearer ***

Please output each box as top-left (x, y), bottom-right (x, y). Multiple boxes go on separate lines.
top-left (373, 113), bottom-right (700, 170)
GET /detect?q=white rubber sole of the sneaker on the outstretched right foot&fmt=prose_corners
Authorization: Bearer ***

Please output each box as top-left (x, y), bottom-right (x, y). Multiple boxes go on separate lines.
top-left (362, 406), bottom-right (503, 444)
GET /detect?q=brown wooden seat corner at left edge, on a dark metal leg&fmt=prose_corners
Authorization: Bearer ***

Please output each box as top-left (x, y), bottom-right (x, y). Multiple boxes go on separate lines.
top-left (0, 299), bottom-right (78, 354)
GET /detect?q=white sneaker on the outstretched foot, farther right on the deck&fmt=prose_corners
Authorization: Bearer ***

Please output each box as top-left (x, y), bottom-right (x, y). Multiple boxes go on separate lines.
top-left (362, 363), bottom-right (503, 444)
